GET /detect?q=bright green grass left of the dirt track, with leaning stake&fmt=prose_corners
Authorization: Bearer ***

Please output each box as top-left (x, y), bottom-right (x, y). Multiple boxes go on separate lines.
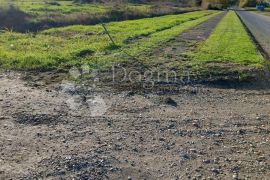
top-left (0, 11), bottom-right (218, 70)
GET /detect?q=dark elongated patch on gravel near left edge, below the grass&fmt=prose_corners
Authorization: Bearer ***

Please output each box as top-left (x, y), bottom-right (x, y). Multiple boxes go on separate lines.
top-left (13, 113), bottom-right (62, 126)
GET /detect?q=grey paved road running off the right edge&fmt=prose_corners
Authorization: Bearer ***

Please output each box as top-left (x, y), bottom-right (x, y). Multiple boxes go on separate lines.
top-left (237, 11), bottom-right (270, 57)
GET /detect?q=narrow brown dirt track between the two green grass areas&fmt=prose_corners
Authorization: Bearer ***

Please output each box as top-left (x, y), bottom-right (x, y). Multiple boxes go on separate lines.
top-left (144, 12), bottom-right (227, 71)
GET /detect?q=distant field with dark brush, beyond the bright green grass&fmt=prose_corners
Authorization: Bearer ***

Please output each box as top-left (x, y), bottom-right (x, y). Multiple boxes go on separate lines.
top-left (0, 0), bottom-right (199, 32)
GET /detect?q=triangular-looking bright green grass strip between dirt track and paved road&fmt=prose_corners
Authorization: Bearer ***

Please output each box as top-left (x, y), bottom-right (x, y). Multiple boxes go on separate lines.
top-left (193, 11), bottom-right (263, 67)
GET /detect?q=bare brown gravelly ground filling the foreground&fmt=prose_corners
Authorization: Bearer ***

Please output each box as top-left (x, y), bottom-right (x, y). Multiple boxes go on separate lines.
top-left (0, 71), bottom-right (270, 179)
